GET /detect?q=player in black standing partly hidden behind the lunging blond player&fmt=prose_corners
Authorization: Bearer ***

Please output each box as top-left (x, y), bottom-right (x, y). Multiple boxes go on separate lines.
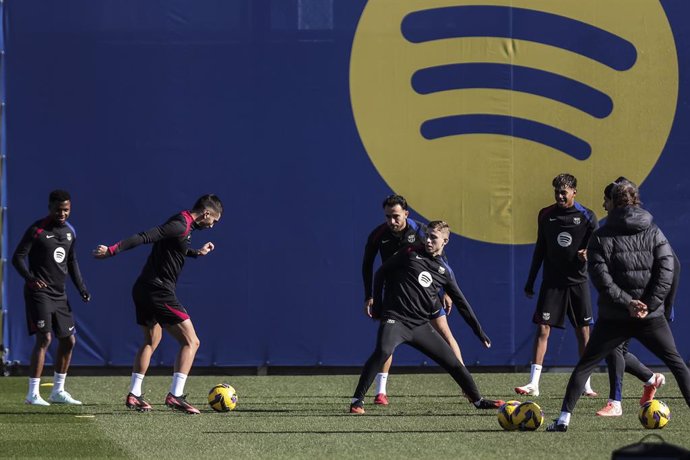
top-left (362, 195), bottom-right (463, 405)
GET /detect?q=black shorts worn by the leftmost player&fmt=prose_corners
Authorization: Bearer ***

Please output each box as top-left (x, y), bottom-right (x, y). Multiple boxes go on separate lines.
top-left (24, 288), bottom-right (75, 338)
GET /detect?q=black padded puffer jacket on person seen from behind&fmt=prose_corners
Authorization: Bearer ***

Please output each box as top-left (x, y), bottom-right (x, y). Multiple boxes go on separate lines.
top-left (587, 206), bottom-right (674, 321)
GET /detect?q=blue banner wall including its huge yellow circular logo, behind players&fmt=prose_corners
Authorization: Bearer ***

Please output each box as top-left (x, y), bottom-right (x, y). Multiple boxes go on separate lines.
top-left (4, 0), bottom-right (690, 366)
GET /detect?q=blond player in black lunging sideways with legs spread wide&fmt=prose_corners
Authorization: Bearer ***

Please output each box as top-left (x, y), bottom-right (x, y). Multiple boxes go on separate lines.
top-left (350, 221), bottom-right (503, 414)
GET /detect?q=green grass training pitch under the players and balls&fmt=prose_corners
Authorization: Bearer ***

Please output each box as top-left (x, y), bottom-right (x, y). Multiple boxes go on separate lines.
top-left (0, 373), bottom-right (690, 460)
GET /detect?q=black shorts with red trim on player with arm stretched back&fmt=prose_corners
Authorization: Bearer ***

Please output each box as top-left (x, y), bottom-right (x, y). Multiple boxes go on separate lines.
top-left (132, 281), bottom-right (189, 327)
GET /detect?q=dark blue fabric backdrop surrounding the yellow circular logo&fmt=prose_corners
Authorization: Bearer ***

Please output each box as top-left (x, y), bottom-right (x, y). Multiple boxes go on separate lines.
top-left (5, 0), bottom-right (690, 366)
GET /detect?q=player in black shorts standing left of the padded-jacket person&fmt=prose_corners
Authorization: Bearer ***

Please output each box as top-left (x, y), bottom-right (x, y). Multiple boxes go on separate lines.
top-left (515, 174), bottom-right (598, 397)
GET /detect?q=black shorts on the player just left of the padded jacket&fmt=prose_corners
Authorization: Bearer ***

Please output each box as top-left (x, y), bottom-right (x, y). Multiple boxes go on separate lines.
top-left (532, 283), bottom-right (593, 329)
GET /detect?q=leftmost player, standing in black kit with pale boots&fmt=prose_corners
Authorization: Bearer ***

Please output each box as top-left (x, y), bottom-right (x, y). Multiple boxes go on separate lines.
top-left (12, 190), bottom-right (91, 406)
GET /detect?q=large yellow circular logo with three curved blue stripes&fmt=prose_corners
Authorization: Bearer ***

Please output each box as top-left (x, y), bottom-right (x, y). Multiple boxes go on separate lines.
top-left (350, 0), bottom-right (678, 244)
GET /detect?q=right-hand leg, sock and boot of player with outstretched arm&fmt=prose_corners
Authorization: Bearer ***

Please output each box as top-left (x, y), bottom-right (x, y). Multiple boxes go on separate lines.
top-left (165, 319), bottom-right (199, 414)
